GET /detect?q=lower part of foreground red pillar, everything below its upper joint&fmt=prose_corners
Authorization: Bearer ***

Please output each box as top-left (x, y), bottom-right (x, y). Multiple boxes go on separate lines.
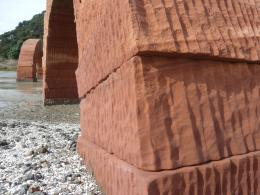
top-left (78, 56), bottom-right (260, 195)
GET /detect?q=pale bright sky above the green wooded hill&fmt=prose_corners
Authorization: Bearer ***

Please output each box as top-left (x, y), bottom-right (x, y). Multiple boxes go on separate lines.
top-left (0, 0), bottom-right (46, 35)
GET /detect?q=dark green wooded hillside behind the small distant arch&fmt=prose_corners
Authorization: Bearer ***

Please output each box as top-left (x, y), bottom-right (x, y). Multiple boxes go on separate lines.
top-left (0, 12), bottom-right (44, 59)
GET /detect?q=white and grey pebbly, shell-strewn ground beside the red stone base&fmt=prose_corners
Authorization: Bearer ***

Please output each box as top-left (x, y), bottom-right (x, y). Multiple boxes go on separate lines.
top-left (0, 120), bottom-right (101, 195)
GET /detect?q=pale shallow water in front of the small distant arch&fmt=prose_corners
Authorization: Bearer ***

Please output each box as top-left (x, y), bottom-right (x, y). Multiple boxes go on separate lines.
top-left (0, 71), bottom-right (42, 108)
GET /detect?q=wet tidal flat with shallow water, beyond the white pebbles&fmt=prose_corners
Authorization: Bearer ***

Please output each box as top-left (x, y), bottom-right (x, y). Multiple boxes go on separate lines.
top-left (0, 71), bottom-right (79, 123)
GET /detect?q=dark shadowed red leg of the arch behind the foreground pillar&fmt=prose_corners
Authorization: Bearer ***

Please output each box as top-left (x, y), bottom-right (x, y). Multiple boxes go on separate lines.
top-left (43, 0), bottom-right (78, 104)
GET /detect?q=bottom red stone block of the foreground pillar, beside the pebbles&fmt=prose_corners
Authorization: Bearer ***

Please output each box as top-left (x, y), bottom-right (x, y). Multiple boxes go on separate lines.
top-left (78, 137), bottom-right (260, 195)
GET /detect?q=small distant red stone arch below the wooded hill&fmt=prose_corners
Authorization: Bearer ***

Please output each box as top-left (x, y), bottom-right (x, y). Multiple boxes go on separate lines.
top-left (17, 39), bottom-right (43, 81)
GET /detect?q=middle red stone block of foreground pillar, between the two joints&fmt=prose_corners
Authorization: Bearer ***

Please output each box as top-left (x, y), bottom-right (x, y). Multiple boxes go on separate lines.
top-left (81, 57), bottom-right (260, 170)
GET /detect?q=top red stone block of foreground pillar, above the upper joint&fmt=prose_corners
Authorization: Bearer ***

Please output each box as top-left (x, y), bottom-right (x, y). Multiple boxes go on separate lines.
top-left (74, 0), bottom-right (260, 97)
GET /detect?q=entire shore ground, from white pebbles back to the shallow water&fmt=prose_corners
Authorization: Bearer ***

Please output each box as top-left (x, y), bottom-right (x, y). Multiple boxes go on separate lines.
top-left (0, 71), bottom-right (101, 195)
